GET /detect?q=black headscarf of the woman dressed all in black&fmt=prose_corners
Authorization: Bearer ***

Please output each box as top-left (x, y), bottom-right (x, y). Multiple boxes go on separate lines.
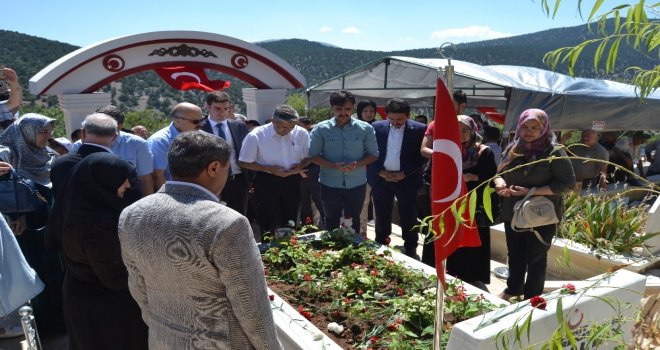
top-left (61, 152), bottom-right (135, 228)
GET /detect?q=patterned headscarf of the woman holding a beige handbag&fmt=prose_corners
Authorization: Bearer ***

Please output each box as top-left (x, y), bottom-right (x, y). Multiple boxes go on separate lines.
top-left (497, 108), bottom-right (556, 171)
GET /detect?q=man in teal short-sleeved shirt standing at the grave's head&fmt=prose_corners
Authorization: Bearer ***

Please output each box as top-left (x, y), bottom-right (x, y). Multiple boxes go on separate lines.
top-left (309, 91), bottom-right (378, 232)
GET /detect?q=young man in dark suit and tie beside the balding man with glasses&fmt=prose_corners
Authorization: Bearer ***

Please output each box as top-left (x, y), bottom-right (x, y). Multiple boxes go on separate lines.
top-left (202, 91), bottom-right (251, 215)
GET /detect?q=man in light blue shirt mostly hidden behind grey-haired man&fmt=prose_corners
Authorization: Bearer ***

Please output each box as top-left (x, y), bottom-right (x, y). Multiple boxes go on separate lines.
top-left (71, 105), bottom-right (154, 196)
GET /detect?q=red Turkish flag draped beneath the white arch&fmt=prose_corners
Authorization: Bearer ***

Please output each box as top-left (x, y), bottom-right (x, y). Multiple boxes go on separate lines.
top-left (154, 66), bottom-right (231, 92)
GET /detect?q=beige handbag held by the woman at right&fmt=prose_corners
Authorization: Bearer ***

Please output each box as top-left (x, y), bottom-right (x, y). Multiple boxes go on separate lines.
top-left (511, 187), bottom-right (559, 245)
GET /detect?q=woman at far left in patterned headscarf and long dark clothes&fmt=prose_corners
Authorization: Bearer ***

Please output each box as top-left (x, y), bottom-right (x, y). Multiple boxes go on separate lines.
top-left (0, 113), bottom-right (65, 335)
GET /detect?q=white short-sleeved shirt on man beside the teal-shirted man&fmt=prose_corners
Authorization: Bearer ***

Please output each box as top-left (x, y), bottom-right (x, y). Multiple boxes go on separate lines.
top-left (238, 123), bottom-right (309, 170)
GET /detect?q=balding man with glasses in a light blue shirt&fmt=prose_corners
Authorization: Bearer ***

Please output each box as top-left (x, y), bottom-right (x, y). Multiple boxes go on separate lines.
top-left (147, 102), bottom-right (205, 190)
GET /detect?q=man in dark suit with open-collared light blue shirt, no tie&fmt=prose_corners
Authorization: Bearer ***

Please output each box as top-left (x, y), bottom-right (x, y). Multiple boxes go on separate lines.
top-left (367, 98), bottom-right (426, 257)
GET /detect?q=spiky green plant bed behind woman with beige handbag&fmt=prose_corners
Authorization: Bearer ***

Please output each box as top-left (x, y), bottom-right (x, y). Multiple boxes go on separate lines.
top-left (557, 193), bottom-right (657, 253)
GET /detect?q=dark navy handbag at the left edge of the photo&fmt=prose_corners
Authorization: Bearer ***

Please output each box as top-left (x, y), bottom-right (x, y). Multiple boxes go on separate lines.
top-left (0, 169), bottom-right (48, 214)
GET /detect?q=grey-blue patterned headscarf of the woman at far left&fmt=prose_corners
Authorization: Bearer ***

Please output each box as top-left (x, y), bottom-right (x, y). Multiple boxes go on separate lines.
top-left (0, 113), bottom-right (55, 186)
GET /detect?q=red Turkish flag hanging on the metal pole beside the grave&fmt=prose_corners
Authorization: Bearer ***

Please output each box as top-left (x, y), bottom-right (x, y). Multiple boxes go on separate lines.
top-left (431, 79), bottom-right (481, 290)
